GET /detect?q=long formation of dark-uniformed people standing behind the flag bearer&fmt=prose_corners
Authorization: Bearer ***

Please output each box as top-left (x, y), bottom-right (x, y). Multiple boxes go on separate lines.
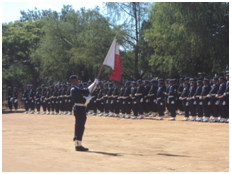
top-left (7, 74), bottom-right (229, 123)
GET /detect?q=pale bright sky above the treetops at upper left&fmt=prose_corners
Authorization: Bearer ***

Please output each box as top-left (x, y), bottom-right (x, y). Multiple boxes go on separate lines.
top-left (1, 0), bottom-right (103, 23)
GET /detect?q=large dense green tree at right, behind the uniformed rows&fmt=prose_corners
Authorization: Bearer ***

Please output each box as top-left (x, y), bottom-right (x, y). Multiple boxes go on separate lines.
top-left (145, 2), bottom-right (229, 77)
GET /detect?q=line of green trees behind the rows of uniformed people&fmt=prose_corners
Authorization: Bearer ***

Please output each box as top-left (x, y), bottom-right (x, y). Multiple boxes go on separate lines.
top-left (2, 2), bottom-right (229, 91)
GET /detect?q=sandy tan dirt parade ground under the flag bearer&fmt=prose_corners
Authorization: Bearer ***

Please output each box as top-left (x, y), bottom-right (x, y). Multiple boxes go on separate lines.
top-left (2, 110), bottom-right (229, 172)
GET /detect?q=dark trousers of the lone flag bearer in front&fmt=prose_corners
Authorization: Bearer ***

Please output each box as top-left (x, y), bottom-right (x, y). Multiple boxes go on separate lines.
top-left (74, 106), bottom-right (87, 141)
